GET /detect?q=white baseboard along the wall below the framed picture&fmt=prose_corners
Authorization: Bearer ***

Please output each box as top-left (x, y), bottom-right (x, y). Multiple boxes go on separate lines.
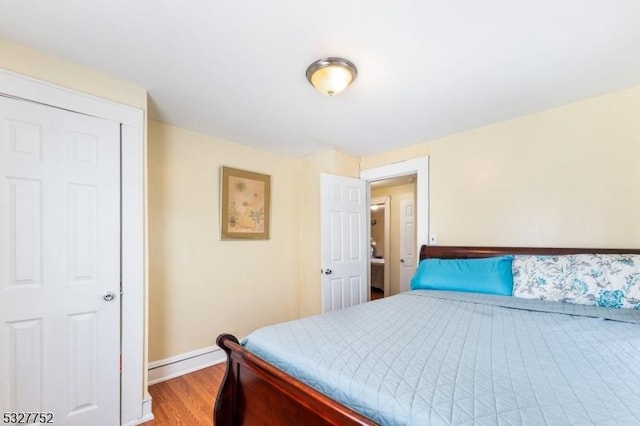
top-left (149, 345), bottom-right (227, 385)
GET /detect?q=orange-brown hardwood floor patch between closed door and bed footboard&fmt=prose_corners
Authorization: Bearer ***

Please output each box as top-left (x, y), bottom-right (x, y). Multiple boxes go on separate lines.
top-left (143, 363), bottom-right (225, 426)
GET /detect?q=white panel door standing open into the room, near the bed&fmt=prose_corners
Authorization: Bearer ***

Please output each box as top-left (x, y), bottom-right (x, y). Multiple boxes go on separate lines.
top-left (320, 173), bottom-right (369, 312)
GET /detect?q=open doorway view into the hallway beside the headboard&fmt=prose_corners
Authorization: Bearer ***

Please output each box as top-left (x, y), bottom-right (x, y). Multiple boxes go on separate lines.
top-left (369, 173), bottom-right (416, 300)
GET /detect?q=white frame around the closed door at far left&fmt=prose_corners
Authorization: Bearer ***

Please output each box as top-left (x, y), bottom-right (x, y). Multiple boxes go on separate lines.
top-left (0, 68), bottom-right (144, 425)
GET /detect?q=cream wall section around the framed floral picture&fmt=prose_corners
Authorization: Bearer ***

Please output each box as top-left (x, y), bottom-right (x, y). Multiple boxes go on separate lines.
top-left (148, 120), bottom-right (300, 361)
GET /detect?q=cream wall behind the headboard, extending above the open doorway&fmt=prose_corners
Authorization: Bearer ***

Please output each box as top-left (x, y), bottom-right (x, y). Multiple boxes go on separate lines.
top-left (362, 87), bottom-right (640, 247)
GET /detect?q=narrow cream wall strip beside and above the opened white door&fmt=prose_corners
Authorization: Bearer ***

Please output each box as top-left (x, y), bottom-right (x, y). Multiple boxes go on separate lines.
top-left (297, 151), bottom-right (360, 316)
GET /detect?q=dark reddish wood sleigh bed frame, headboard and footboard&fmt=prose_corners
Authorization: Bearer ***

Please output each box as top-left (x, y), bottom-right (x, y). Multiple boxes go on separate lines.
top-left (214, 245), bottom-right (640, 426)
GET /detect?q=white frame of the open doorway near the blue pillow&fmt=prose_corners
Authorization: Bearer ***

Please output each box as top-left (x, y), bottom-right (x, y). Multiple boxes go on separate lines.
top-left (360, 156), bottom-right (429, 272)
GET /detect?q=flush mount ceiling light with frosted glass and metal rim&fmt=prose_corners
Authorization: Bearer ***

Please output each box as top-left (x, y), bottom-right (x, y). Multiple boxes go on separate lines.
top-left (307, 58), bottom-right (358, 96)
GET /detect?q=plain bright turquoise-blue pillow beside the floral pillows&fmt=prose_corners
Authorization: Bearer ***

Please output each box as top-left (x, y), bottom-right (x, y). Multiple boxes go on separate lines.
top-left (411, 256), bottom-right (513, 296)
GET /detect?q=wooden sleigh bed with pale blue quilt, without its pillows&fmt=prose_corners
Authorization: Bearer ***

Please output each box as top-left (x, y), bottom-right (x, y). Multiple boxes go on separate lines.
top-left (214, 246), bottom-right (640, 426)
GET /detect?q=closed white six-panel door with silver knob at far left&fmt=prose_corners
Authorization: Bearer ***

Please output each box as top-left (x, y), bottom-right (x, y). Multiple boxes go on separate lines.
top-left (0, 97), bottom-right (120, 426)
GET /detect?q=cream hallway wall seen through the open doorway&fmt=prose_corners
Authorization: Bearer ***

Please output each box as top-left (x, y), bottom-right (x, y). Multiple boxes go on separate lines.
top-left (371, 183), bottom-right (415, 295)
